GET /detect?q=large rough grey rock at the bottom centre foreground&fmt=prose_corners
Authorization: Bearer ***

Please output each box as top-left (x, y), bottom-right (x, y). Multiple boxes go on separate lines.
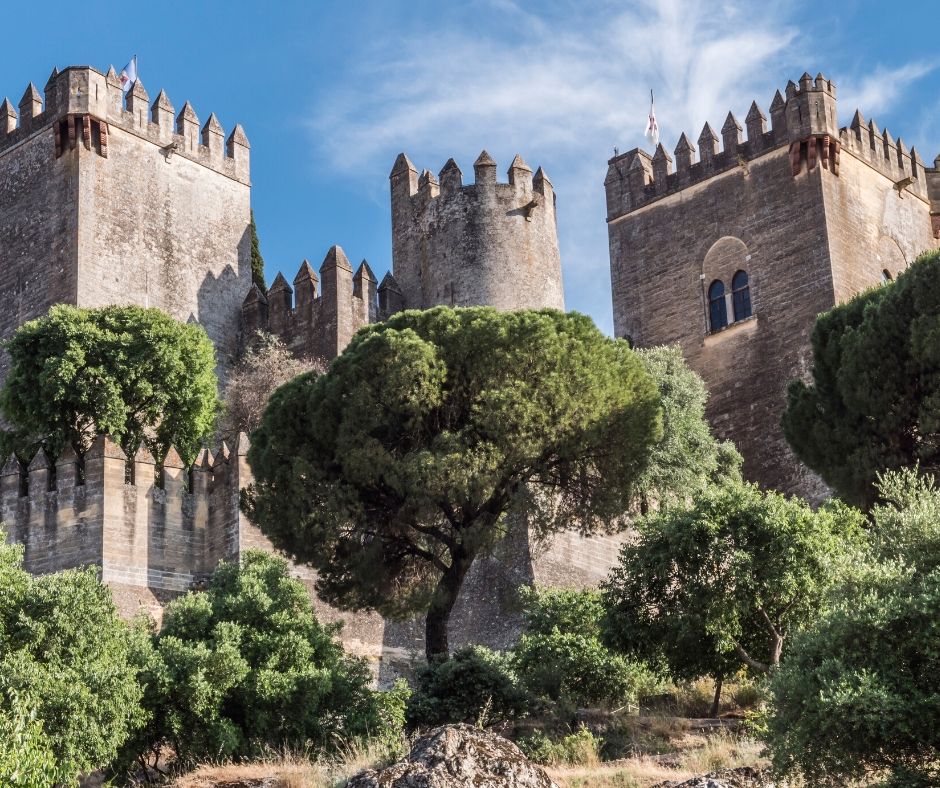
top-left (346, 725), bottom-right (558, 788)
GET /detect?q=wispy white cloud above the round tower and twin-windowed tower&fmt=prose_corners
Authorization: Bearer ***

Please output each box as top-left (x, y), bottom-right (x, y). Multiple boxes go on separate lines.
top-left (312, 0), bottom-right (926, 330)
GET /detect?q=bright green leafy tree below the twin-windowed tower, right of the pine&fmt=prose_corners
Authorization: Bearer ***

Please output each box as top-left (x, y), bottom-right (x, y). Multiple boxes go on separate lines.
top-left (606, 483), bottom-right (862, 679)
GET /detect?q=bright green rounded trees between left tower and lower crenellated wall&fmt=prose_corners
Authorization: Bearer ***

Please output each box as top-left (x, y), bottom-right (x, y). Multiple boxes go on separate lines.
top-left (0, 305), bottom-right (218, 460)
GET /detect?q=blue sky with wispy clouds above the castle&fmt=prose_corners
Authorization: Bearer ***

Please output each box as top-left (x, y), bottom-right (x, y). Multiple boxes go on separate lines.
top-left (0, 0), bottom-right (940, 331)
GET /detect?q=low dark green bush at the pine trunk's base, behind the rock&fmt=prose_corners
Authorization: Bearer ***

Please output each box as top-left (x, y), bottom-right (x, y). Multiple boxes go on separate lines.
top-left (408, 646), bottom-right (529, 727)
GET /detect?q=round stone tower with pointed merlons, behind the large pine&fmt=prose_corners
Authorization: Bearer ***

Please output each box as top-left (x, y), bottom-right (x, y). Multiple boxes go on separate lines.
top-left (390, 151), bottom-right (565, 311)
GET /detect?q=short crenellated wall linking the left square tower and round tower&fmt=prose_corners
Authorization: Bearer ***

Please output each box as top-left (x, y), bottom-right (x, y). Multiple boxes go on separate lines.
top-left (242, 246), bottom-right (378, 359)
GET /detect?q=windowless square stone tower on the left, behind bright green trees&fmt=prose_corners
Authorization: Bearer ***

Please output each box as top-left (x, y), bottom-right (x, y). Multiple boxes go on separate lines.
top-left (0, 66), bottom-right (251, 371)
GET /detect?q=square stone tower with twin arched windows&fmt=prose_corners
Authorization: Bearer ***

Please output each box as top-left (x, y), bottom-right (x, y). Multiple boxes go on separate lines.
top-left (605, 69), bottom-right (940, 499)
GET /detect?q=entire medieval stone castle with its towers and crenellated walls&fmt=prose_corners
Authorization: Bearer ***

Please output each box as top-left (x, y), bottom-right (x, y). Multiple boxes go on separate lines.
top-left (0, 61), bottom-right (940, 662)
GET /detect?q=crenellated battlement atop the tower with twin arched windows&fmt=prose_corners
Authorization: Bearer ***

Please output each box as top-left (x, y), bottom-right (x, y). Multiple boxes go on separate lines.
top-left (604, 72), bottom-right (940, 221)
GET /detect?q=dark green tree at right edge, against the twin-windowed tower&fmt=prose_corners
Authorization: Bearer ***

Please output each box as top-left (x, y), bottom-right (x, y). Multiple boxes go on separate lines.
top-left (783, 252), bottom-right (940, 507)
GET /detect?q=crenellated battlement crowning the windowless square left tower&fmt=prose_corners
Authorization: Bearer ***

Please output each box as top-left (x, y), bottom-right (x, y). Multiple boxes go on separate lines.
top-left (0, 66), bottom-right (250, 184)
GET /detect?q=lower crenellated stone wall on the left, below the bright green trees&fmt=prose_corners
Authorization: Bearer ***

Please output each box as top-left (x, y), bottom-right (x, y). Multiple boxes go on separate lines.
top-left (0, 435), bottom-right (255, 593)
